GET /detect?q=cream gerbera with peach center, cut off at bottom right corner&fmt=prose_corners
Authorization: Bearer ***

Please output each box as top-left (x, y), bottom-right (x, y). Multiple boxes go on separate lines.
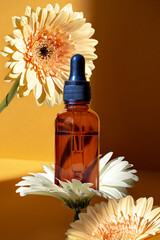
top-left (66, 196), bottom-right (160, 240)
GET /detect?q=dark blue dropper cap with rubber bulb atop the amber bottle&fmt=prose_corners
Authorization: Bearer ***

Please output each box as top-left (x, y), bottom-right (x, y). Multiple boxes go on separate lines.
top-left (63, 54), bottom-right (91, 102)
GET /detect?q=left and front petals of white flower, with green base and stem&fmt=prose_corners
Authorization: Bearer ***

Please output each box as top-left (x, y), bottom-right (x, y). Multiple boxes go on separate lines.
top-left (16, 164), bottom-right (96, 220)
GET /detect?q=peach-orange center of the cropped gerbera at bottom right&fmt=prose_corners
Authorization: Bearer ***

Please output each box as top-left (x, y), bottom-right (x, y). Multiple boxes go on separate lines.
top-left (91, 215), bottom-right (145, 240)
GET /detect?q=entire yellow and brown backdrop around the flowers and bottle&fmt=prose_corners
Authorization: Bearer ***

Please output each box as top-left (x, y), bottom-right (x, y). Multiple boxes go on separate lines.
top-left (0, 0), bottom-right (160, 240)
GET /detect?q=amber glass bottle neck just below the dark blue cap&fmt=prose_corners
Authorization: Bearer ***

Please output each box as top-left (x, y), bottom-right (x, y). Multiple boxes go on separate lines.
top-left (65, 101), bottom-right (90, 110)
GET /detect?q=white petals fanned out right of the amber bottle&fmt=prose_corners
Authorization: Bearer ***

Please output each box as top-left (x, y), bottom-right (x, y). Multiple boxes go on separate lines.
top-left (99, 152), bottom-right (138, 199)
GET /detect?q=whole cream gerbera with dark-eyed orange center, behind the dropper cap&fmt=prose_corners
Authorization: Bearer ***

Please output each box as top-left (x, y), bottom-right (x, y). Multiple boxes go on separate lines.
top-left (1, 4), bottom-right (97, 106)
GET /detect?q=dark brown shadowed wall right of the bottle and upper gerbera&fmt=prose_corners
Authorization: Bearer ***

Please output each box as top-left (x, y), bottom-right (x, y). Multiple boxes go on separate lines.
top-left (92, 0), bottom-right (160, 170)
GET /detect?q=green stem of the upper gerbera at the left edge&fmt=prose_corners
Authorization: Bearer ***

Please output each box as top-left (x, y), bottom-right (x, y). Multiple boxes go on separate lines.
top-left (0, 79), bottom-right (19, 113)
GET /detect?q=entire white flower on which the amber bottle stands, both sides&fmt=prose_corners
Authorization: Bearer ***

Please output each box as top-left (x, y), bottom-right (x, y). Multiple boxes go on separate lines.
top-left (16, 153), bottom-right (138, 219)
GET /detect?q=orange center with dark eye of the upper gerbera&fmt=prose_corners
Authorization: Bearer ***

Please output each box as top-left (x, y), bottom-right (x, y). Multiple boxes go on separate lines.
top-left (25, 29), bottom-right (74, 77)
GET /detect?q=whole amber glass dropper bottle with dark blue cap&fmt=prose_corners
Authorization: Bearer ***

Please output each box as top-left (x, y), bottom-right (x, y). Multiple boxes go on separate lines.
top-left (55, 54), bottom-right (100, 189)
